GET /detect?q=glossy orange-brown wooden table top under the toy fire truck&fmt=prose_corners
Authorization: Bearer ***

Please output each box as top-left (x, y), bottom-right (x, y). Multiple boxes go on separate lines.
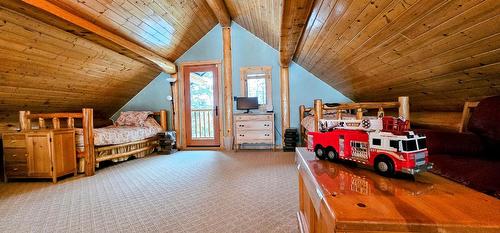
top-left (296, 148), bottom-right (500, 232)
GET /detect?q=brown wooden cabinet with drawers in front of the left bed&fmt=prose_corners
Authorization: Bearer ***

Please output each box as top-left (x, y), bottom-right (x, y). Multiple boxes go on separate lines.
top-left (2, 129), bottom-right (76, 183)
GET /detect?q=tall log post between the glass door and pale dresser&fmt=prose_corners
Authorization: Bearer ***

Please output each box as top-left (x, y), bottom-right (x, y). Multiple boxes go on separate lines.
top-left (222, 27), bottom-right (233, 150)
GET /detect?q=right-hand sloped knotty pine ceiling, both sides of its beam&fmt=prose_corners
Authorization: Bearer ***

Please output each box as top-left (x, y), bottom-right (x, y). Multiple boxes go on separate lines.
top-left (225, 0), bottom-right (500, 111)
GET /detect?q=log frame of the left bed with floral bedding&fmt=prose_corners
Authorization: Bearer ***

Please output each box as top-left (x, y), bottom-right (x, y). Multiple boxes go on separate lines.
top-left (19, 108), bottom-right (167, 176)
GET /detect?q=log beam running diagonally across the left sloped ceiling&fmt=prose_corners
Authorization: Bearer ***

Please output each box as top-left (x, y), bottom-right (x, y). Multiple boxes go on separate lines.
top-left (23, 0), bottom-right (176, 74)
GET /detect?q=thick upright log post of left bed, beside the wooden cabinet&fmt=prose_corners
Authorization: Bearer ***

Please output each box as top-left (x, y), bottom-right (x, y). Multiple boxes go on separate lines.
top-left (82, 108), bottom-right (95, 176)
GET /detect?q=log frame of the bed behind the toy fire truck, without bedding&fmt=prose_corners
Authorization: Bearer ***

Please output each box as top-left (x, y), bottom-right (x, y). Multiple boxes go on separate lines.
top-left (299, 96), bottom-right (410, 143)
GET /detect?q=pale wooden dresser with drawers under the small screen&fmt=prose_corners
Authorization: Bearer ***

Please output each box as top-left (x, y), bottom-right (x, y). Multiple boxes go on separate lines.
top-left (234, 113), bottom-right (275, 149)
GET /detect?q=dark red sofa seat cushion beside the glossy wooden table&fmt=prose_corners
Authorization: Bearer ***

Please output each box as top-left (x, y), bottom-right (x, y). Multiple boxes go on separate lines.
top-left (429, 154), bottom-right (500, 198)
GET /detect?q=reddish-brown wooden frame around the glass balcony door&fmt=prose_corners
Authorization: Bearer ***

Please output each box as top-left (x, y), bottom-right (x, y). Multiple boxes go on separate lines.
top-left (177, 60), bottom-right (224, 149)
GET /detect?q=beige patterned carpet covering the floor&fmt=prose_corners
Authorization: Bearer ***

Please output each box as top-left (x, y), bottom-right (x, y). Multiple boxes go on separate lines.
top-left (0, 151), bottom-right (298, 233)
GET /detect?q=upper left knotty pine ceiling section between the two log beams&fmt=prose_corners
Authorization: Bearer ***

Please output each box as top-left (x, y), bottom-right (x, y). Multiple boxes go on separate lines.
top-left (45, 0), bottom-right (218, 61)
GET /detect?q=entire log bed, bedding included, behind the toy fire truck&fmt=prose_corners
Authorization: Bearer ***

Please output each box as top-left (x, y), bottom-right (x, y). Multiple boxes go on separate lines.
top-left (299, 96), bottom-right (410, 145)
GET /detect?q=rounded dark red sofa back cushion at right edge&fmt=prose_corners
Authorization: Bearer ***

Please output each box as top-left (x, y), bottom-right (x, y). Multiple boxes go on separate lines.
top-left (468, 96), bottom-right (500, 156)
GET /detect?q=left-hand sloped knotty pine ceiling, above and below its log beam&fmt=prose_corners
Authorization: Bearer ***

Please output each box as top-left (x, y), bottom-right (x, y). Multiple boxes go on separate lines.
top-left (0, 0), bottom-right (217, 129)
